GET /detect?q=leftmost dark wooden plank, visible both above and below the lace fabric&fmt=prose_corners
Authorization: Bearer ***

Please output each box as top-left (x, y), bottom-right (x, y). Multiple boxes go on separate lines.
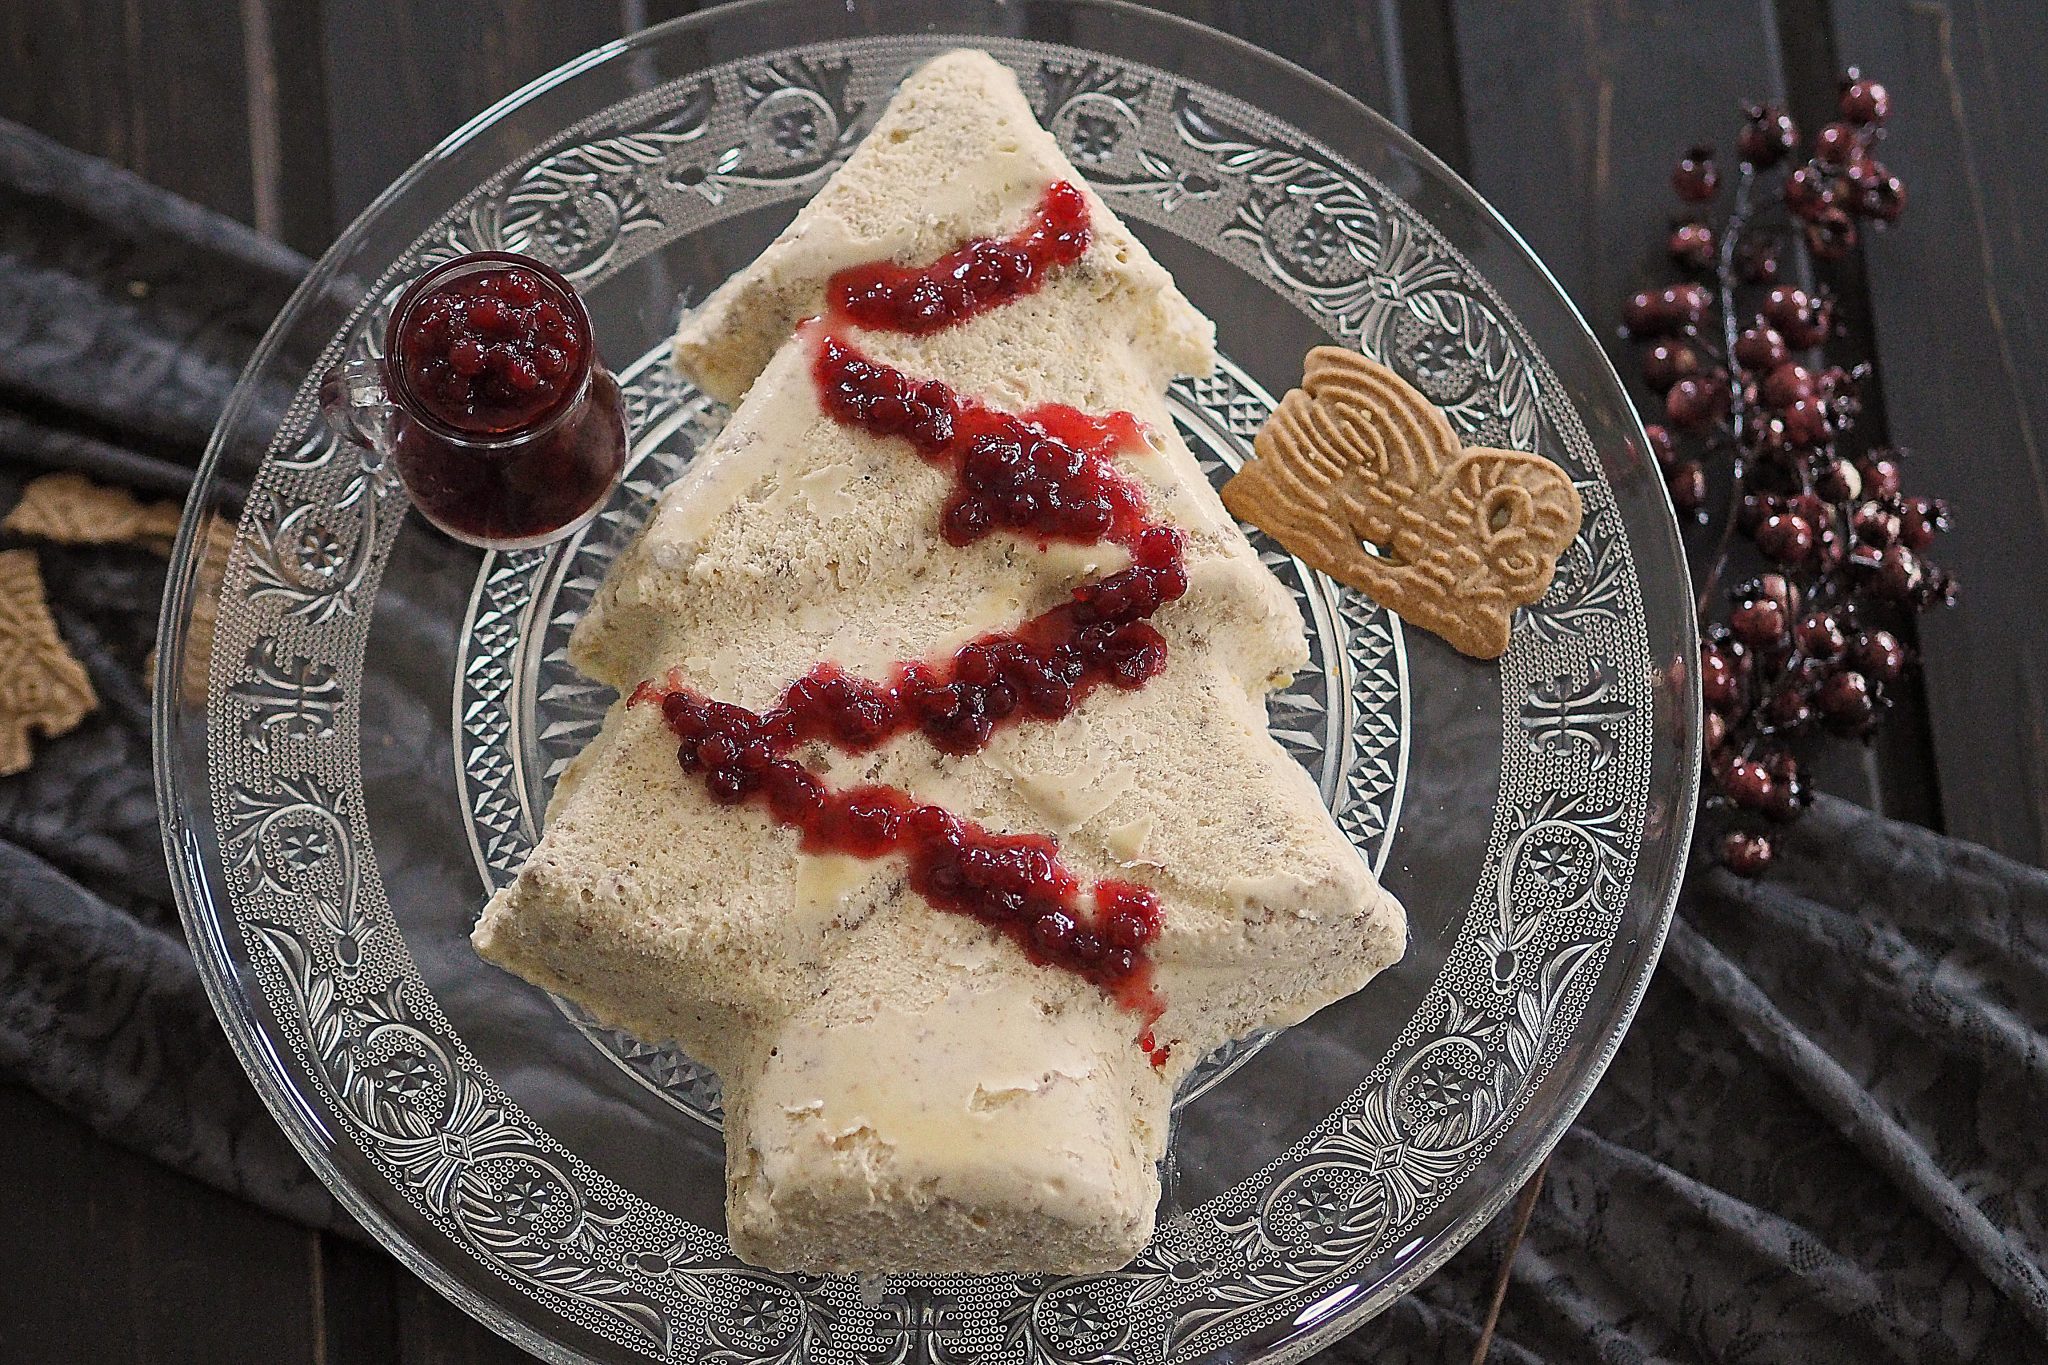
top-left (0, 0), bottom-right (346, 1363)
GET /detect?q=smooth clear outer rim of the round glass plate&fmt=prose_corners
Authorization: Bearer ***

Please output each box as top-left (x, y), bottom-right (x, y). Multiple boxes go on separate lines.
top-left (154, 0), bottom-right (1700, 1361)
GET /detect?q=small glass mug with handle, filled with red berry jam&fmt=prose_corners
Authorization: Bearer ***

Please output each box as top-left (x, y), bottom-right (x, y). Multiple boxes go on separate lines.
top-left (319, 252), bottom-right (627, 548)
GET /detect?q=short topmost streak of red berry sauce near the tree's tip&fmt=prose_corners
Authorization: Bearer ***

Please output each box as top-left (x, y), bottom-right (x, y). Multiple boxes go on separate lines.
top-left (825, 180), bottom-right (1092, 334)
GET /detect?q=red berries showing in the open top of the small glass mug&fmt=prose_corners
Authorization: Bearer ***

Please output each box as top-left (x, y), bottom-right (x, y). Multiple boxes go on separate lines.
top-left (395, 266), bottom-right (588, 436)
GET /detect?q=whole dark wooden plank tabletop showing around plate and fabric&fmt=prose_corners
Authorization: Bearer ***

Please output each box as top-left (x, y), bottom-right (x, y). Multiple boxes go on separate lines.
top-left (0, 0), bottom-right (2048, 1365)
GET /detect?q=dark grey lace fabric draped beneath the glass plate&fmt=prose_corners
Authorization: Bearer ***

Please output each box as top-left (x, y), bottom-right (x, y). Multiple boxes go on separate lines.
top-left (0, 123), bottom-right (2048, 1365)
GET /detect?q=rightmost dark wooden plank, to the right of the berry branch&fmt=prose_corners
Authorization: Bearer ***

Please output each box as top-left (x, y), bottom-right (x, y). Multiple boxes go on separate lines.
top-left (1833, 0), bottom-right (2048, 864)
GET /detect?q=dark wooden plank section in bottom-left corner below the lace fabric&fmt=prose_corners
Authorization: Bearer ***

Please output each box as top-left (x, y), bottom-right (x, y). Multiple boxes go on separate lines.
top-left (0, 1085), bottom-right (322, 1365)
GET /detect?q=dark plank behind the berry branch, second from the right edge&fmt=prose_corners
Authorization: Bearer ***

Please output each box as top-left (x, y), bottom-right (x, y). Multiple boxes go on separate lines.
top-left (1452, 0), bottom-right (1942, 825)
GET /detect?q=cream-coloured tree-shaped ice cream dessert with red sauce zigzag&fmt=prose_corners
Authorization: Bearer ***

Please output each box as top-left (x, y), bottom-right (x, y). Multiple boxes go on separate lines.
top-left (475, 51), bottom-right (1405, 1273)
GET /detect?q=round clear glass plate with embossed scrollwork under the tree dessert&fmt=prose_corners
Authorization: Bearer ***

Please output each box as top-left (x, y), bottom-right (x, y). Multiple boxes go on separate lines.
top-left (156, 0), bottom-right (1698, 1365)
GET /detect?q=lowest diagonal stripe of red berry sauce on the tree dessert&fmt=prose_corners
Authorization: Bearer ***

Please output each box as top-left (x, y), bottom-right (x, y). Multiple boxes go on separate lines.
top-left (633, 684), bottom-right (1159, 994)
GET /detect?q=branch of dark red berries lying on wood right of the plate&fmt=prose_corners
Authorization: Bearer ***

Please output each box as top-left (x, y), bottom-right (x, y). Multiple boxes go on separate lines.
top-left (1622, 68), bottom-right (1956, 876)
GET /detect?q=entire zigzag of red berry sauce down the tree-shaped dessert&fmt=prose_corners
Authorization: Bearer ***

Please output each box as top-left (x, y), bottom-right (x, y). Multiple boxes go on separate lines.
top-left (633, 182), bottom-right (1188, 1066)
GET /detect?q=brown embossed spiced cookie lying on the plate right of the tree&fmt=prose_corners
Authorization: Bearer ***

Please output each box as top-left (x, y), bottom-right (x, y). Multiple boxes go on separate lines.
top-left (1223, 346), bottom-right (1583, 659)
